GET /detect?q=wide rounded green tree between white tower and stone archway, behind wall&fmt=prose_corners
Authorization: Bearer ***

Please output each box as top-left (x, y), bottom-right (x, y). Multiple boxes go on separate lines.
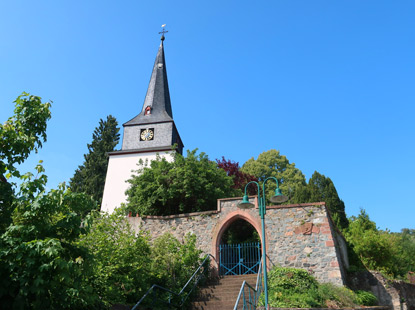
top-left (126, 150), bottom-right (235, 215)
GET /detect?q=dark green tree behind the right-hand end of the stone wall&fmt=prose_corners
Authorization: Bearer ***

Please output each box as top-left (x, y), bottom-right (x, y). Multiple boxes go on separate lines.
top-left (307, 171), bottom-right (349, 229)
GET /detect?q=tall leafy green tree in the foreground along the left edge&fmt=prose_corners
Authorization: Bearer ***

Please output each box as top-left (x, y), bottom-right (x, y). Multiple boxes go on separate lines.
top-left (0, 93), bottom-right (101, 309)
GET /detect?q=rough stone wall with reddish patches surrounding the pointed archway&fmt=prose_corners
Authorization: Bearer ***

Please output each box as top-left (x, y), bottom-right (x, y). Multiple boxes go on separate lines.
top-left (128, 197), bottom-right (347, 285)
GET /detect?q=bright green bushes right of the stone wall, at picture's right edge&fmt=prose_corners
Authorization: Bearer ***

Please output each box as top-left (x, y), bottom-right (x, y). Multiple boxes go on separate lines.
top-left (345, 210), bottom-right (415, 278)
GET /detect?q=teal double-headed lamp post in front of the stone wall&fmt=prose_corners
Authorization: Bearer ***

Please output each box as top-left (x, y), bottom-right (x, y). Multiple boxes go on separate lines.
top-left (238, 177), bottom-right (288, 309)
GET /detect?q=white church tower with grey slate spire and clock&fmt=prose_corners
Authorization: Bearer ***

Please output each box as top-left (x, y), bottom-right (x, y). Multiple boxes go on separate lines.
top-left (101, 34), bottom-right (183, 212)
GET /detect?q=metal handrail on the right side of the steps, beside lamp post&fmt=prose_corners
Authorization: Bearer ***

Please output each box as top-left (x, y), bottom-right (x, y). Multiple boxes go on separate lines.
top-left (233, 262), bottom-right (263, 310)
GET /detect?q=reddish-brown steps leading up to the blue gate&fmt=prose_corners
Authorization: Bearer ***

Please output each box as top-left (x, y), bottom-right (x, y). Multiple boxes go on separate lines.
top-left (191, 274), bottom-right (257, 310)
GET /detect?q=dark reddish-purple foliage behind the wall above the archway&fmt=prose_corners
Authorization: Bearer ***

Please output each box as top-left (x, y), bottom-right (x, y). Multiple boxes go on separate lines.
top-left (216, 156), bottom-right (258, 196)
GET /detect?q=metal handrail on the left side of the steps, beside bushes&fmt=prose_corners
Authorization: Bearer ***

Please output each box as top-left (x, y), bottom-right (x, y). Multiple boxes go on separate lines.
top-left (131, 254), bottom-right (215, 310)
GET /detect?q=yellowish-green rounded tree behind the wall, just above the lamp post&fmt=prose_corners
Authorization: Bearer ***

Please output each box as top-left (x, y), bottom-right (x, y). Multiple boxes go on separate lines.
top-left (241, 150), bottom-right (306, 203)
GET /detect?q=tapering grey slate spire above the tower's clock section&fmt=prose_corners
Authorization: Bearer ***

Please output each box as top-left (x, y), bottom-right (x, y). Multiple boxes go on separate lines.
top-left (123, 40), bottom-right (173, 126)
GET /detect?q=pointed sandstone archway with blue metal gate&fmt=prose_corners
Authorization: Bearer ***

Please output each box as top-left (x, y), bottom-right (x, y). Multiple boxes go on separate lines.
top-left (212, 210), bottom-right (262, 275)
